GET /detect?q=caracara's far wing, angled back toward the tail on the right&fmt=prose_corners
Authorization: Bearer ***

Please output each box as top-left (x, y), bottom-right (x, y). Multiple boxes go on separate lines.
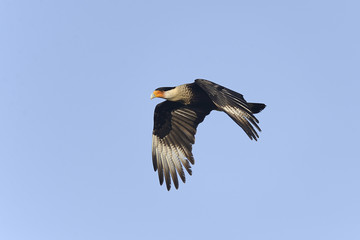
top-left (195, 79), bottom-right (265, 140)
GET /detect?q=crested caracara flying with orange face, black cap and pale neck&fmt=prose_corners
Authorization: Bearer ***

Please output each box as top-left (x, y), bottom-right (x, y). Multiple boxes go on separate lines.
top-left (151, 79), bottom-right (266, 190)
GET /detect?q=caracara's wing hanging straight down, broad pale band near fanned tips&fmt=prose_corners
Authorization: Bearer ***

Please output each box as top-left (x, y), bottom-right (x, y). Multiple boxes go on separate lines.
top-left (152, 101), bottom-right (211, 190)
